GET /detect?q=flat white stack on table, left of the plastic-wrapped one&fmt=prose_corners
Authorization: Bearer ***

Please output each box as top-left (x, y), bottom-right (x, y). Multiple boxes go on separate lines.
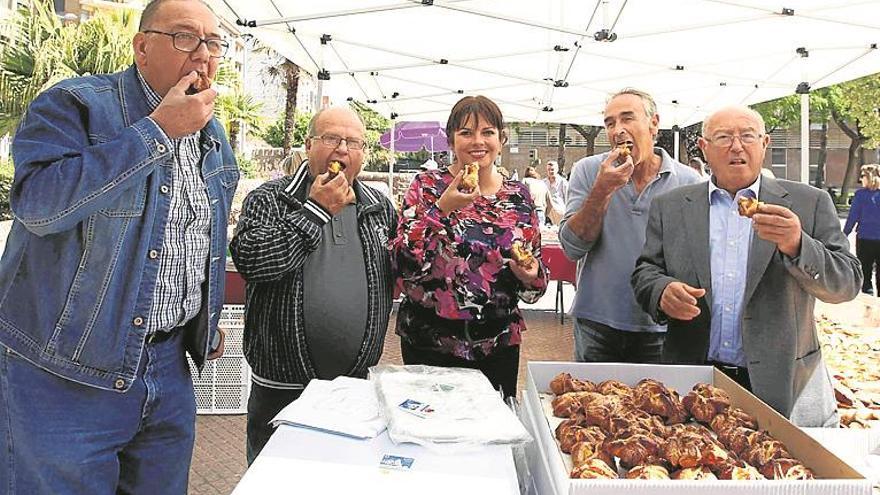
top-left (271, 376), bottom-right (386, 438)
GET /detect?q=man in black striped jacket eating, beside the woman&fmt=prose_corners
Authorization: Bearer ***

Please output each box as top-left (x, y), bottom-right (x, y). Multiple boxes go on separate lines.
top-left (230, 108), bottom-right (397, 464)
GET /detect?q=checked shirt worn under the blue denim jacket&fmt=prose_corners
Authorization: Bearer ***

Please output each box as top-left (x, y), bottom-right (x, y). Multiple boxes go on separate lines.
top-left (138, 71), bottom-right (211, 333)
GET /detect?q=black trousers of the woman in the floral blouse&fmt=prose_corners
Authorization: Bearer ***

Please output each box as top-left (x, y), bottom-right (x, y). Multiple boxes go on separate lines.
top-left (400, 340), bottom-right (519, 399)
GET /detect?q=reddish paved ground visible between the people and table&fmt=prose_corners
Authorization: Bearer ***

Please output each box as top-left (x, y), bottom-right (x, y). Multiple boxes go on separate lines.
top-left (189, 283), bottom-right (574, 495)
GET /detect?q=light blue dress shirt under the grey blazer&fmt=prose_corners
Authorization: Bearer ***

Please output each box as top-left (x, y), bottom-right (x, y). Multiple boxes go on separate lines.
top-left (708, 176), bottom-right (761, 367)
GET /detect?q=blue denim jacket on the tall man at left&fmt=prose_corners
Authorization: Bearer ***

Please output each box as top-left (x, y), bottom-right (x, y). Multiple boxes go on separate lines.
top-left (0, 66), bottom-right (239, 392)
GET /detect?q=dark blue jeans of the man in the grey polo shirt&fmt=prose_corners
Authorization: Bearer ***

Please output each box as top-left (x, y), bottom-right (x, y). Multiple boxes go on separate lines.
top-left (574, 318), bottom-right (666, 363)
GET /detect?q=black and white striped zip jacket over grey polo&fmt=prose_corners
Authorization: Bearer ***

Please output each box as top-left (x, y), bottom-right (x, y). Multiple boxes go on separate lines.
top-left (230, 163), bottom-right (397, 388)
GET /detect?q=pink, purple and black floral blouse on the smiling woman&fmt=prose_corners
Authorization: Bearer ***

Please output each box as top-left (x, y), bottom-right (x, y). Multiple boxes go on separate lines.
top-left (391, 168), bottom-right (548, 360)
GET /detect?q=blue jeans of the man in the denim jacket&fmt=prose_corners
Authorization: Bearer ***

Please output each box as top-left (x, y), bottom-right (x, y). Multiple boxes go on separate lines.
top-left (0, 331), bottom-right (195, 495)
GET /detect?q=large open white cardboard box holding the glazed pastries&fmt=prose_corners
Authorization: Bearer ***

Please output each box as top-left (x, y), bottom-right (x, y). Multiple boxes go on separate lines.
top-left (523, 362), bottom-right (871, 495)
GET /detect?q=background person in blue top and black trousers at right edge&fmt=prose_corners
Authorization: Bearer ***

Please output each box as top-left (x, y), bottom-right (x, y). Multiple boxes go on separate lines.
top-left (843, 164), bottom-right (880, 297)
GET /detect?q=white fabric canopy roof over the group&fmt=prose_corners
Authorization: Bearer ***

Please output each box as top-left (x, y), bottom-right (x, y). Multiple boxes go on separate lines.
top-left (209, 0), bottom-right (880, 128)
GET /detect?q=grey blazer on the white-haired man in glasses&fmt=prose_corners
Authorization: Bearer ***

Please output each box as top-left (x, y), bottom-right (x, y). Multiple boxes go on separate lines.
top-left (632, 177), bottom-right (862, 426)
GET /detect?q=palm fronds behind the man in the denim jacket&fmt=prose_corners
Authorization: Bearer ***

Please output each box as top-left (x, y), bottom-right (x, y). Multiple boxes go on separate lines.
top-left (0, 0), bottom-right (138, 135)
